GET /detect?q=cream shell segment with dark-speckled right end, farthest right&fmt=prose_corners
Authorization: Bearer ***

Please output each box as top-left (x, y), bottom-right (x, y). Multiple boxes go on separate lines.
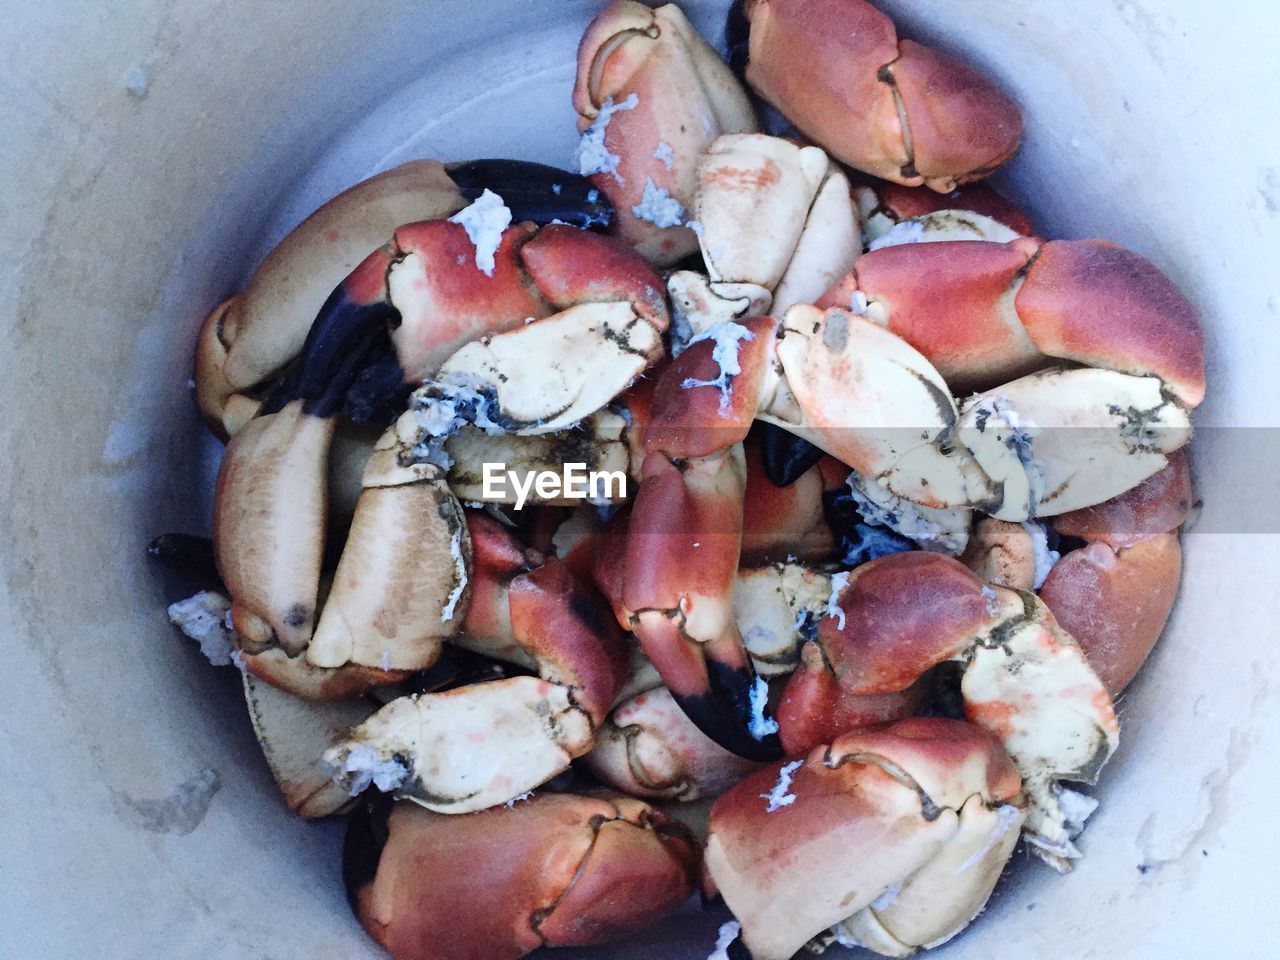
top-left (956, 367), bottom-right (1192, 521)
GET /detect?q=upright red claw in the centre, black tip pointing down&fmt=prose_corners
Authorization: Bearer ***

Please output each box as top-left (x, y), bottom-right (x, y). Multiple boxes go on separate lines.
top-left (614, 317), bottom-right (778, 759)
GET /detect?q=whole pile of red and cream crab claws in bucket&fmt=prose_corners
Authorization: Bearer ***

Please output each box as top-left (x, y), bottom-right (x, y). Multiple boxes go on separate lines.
top-left (155, 0), bottom-right (1204, 960)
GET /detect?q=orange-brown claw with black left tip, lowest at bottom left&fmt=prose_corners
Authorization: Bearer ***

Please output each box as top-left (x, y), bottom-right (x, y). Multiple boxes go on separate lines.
top-left (343, 794), bottom-right (699, 960)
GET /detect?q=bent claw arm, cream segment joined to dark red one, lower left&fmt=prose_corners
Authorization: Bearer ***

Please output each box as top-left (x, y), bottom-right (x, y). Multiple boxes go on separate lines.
top-left (325, 558), bottom-right (627, 813)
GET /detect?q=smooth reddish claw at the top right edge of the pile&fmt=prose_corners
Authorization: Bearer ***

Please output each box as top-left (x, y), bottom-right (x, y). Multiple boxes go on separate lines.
top-left (745, 0), bottom-right (1023, 192)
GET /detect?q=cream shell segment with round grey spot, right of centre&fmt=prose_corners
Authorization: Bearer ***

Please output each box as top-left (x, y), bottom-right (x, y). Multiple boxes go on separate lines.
top-left (759, 303), bottom-right (989, 507)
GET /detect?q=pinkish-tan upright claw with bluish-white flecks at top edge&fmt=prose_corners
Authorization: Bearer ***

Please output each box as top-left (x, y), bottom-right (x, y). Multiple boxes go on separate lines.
top-left (573, 0), bottom-right (756, 266)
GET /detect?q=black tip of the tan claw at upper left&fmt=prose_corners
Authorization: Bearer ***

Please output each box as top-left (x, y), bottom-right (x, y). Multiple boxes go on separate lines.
top-left (449, 160), bottom-right (613, 229)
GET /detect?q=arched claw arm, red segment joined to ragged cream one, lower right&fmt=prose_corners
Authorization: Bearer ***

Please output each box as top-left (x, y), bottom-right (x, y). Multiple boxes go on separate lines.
top-left (780, 552), bottom-right (1119, 869)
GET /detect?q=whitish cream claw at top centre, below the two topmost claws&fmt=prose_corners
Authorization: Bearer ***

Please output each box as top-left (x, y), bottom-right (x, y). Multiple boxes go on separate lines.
top-left (668, 133), bottom-right (861, 335)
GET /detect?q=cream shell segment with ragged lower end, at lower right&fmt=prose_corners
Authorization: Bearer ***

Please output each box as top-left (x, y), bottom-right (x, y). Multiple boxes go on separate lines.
top-left (960, 588), bottom-right (1120, 872)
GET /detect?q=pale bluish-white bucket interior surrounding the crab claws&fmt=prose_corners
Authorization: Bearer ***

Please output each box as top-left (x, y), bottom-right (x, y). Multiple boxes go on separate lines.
top-left (0, 0), bottom-right (1280, 960)
